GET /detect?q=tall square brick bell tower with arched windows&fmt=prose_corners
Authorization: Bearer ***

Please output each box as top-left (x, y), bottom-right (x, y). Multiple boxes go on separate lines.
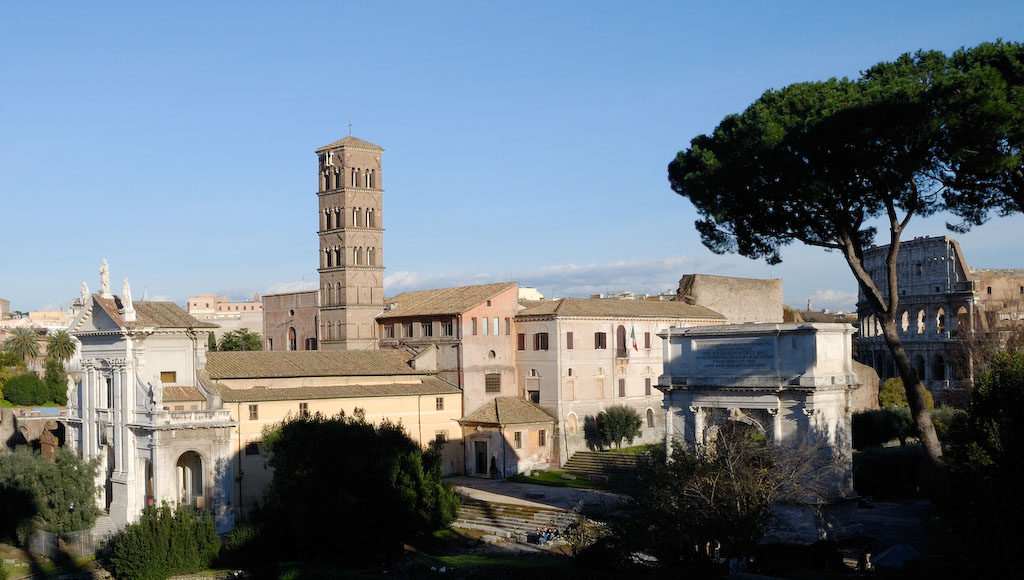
top-left (316, 135), bottom-right (384, 350)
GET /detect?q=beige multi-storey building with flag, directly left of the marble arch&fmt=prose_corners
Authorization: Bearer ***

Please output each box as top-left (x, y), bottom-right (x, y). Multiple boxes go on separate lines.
top-left (516, 298), bottom-right (724, 465)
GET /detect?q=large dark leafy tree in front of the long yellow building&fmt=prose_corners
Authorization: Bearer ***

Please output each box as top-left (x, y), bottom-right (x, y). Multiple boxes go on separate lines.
top-left (256, 414), bottom-right (459, 562)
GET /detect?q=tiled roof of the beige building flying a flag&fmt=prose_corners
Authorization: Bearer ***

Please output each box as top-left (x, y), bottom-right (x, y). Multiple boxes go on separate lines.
top-left (516, 298), bottom-right (725, 320)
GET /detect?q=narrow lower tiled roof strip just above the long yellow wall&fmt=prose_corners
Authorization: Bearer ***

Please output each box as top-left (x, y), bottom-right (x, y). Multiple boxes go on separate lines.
top-left (213, 376), bottom-right (462, 404)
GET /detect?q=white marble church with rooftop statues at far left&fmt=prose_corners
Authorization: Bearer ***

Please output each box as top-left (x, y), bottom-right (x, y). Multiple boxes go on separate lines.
top-left (66, 270), bottom-right (234, 531)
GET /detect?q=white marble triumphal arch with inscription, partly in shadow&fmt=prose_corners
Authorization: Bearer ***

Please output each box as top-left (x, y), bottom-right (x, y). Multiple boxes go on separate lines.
top-left (658, 324), bottom-right (859, 542)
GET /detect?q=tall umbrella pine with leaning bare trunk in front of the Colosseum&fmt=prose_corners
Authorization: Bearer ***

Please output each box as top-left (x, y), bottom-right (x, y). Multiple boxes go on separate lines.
top-left (669, 52), bottom-right (946, 463)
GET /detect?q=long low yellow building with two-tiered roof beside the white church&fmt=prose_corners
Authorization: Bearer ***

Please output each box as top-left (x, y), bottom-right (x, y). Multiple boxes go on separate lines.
top-left (206, 349), bottom-right (464, 513)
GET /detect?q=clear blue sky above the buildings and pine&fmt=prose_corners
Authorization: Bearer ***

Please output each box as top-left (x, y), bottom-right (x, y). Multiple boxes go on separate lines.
top-left (0, 0), bottom-right (1024, 310)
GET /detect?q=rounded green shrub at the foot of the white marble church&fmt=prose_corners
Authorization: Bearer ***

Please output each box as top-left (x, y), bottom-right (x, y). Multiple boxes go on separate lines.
top-left (111, 503), bottom-right (220, 580)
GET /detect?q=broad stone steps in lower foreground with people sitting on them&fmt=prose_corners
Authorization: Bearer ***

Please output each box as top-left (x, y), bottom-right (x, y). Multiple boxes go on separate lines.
top-left (452, 497), bottom-right (577, 542)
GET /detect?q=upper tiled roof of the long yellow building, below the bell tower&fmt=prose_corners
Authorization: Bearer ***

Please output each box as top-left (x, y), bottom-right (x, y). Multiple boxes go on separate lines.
top-left (206, 350), bottom-right (425, 380)
